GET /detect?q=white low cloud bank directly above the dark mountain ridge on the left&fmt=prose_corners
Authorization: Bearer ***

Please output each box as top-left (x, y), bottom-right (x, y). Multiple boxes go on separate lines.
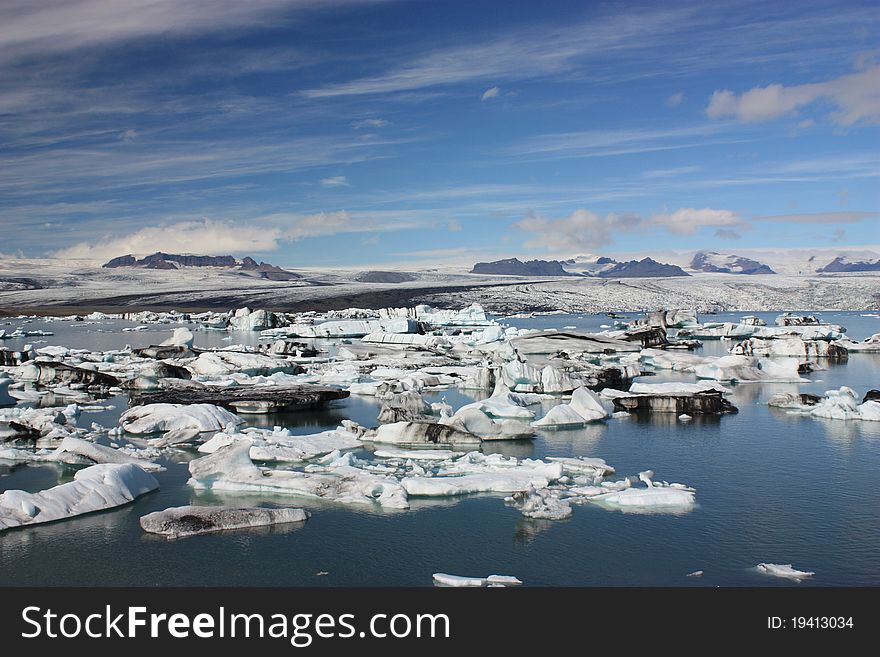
top-left (50, 219), bottom-right (281, 260)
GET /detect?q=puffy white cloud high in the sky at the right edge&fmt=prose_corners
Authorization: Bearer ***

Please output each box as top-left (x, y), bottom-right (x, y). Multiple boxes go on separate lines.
top-left (706, 65), bottom-right (880, 126)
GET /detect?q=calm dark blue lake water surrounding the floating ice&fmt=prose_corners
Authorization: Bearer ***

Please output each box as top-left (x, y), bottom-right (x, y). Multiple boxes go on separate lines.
top-left (0, 313), bottom-right (880, 586)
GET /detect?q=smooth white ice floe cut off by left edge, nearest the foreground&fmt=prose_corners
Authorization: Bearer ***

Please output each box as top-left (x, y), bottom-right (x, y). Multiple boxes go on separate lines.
top-left (0, 463), bottom-right (159, 531)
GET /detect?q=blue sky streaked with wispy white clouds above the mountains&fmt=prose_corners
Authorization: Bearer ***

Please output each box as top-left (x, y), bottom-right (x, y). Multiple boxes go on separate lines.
top-left (0, 0), bottom-right (880, 267)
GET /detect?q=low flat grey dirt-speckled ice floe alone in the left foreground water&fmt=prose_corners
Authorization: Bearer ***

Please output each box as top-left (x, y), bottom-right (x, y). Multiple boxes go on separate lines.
top-left (140, 506), bottom-right (311, 538)
